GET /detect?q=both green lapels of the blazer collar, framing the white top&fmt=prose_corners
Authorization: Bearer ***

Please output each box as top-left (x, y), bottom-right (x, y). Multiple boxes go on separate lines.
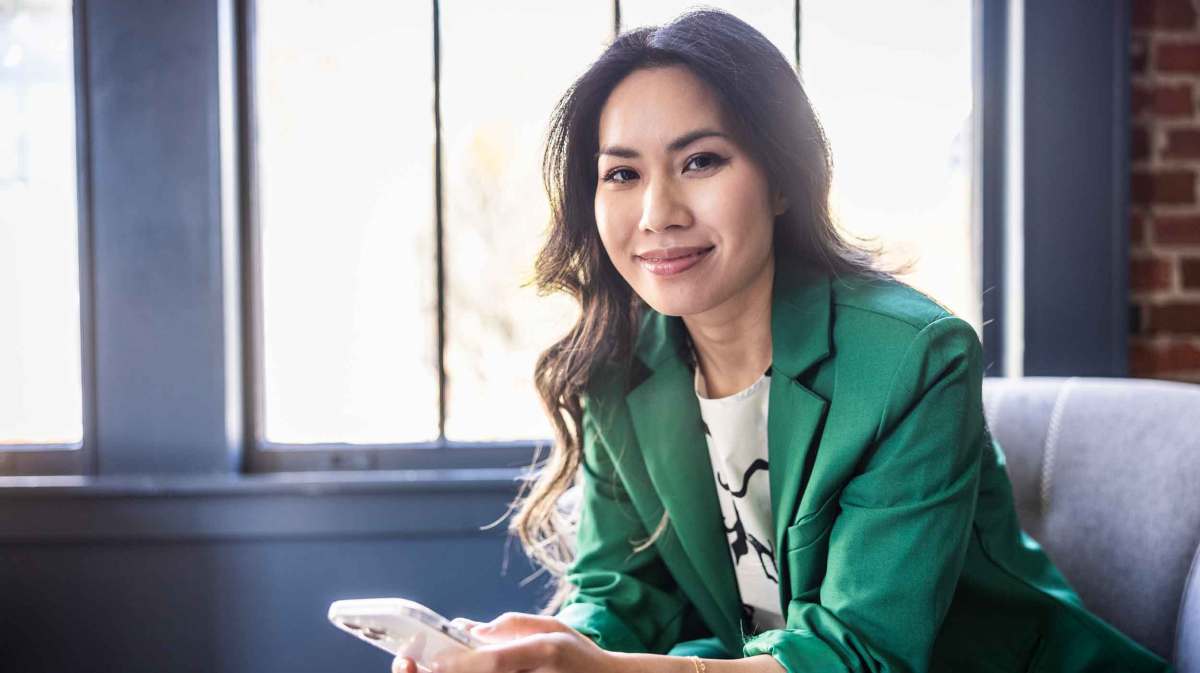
top-left (625, 264), bottom-right (830, 651)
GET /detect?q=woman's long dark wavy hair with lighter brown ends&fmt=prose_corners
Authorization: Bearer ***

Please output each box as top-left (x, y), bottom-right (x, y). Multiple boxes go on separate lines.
top-left (509, 10), bottom-right (890, 613)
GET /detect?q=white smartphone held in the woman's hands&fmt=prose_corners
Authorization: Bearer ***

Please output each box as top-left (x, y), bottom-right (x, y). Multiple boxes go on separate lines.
top-left (329, 599), bottom-right (484, 671)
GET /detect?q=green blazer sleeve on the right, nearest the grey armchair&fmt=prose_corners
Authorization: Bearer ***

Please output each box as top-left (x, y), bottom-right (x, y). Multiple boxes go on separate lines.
top-left (743, 316), bottom-right (985, 673)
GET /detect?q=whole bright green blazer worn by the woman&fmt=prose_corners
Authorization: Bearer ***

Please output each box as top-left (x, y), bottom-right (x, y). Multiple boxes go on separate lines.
top-left (557, 262), bottom-right (1170, 673)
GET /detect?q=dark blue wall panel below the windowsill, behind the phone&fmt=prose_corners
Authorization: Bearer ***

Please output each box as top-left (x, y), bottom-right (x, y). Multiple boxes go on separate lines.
top-left (0, 534), bottom-right (542, 673)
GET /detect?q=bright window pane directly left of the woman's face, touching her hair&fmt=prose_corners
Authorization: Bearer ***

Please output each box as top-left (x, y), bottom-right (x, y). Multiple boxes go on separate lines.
top-left (439, 0), bottom-right (612, 441)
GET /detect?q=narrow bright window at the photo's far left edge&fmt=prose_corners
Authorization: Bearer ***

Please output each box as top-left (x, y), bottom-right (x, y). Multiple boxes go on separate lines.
top-left (0, 0), bottom-right (83, 451)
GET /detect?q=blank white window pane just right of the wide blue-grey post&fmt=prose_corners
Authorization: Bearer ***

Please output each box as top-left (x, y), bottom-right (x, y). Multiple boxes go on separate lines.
top-left (253, 0), bottom-right (438, 444)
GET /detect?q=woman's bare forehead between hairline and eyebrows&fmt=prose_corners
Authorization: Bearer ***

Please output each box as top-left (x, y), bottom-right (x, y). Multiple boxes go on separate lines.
top-left (599, 65), bottom-right (728, 149)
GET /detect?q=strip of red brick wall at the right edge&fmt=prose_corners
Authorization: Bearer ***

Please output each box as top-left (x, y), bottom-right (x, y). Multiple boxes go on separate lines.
top-left (1129, 0), bottom-right (1200, 381)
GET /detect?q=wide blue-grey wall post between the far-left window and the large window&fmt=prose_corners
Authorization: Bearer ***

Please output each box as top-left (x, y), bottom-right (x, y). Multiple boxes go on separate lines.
top-left (80, 0), bottom-right (236, 474)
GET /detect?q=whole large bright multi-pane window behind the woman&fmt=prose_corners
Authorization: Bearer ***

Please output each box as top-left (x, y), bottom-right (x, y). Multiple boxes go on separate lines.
top-left (248, 0), bottom-right (980, 469)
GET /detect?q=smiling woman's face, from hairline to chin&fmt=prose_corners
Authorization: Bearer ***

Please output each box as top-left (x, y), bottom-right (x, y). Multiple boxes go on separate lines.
top-left (595, 66), bottom-right (786, 317)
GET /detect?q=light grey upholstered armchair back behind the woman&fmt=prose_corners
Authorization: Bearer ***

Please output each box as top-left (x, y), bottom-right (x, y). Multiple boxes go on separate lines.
top-left (984, 377), bottom-right (1200, 673)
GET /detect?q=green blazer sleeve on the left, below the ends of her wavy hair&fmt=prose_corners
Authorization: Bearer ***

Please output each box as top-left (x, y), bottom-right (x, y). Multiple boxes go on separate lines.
top-left (556, 398), bottom-right (689, 654)
